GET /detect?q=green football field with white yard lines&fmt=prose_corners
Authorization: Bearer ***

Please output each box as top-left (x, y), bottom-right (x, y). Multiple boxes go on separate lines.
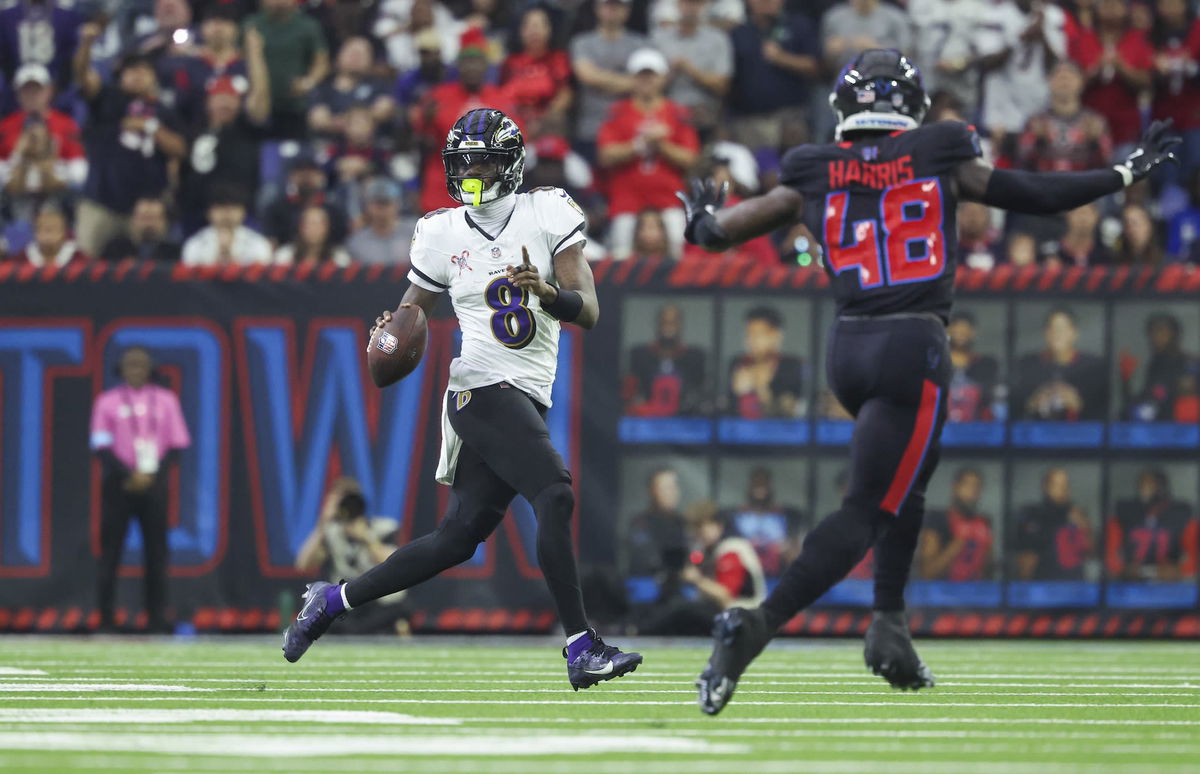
top-left (0, 635), bottom-right (1200, 774)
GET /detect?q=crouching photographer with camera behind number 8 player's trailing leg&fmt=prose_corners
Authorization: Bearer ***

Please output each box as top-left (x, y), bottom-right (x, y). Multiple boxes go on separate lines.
top-left (295, 476), bottom-right (412, 637)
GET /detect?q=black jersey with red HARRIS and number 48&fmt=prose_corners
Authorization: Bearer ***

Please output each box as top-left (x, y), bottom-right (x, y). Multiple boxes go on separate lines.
top-left (781, 121), bottom-right (980, 318)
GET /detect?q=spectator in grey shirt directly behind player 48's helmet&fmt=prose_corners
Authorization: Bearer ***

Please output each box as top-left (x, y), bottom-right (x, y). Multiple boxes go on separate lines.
top-left (825, 0), bottom-right (907, 74)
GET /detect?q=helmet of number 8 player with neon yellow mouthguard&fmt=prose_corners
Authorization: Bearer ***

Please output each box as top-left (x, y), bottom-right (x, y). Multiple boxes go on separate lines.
top-left (442, 108), bottom-right (524, 206)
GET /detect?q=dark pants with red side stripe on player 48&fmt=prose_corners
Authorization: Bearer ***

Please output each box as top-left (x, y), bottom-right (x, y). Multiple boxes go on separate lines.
top-left (763, 314), bottom-right (952, 625)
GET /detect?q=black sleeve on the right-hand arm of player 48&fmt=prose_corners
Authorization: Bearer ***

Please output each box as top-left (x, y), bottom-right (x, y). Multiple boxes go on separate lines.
top-left (983, 169), bottom-right (1124, 215)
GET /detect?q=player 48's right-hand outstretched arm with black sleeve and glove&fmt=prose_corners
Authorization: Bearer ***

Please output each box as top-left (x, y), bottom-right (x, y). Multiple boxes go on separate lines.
top-left (955, 121), bottom-right (1181, 215)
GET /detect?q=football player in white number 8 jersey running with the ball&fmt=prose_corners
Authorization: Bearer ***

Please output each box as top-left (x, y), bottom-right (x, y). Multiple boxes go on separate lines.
top-left (283, 108), bottom-right (642, 690)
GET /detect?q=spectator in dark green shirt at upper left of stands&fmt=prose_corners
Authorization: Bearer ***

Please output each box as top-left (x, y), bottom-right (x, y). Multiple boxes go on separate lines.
top-left (245, 0), bottom-right (329, 138)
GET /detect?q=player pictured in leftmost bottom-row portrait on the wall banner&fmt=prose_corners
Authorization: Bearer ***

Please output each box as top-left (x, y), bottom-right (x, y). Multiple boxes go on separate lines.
top-left (625, 467), bottom-right (688, 577)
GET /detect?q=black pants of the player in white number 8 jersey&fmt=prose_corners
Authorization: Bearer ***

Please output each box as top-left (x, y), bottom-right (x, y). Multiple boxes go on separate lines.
top-left (346, 383), bottom-right (588, 635)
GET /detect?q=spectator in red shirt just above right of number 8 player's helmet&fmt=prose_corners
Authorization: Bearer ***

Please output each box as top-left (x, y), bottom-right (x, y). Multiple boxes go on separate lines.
top-left (500, 6), bottom-right (571, 136)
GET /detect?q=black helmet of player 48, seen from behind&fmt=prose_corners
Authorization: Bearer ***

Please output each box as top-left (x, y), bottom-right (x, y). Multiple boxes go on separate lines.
top-left (829, 48), bottom-right (929, 139)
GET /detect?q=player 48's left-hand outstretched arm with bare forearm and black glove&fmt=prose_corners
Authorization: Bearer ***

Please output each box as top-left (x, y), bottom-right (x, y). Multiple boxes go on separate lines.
top-left (676, 180), bottom-right (804, 252)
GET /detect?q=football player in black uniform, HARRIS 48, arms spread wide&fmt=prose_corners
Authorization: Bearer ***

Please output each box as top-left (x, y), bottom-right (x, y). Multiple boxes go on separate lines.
top-left (679, 49), bottom-right (1178, 714)
